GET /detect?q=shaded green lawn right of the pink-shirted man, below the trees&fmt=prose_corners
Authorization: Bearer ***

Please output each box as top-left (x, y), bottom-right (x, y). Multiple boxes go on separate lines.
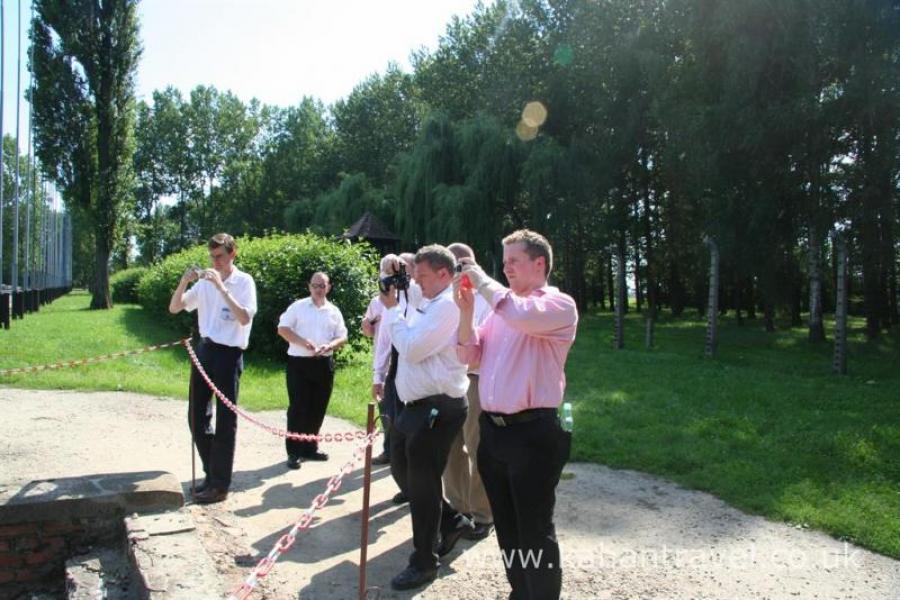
top-left (567, 314), bottom-right (900, 558)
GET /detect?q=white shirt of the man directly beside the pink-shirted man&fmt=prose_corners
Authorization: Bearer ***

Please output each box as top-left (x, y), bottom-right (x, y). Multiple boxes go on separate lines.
top-left (382, 286), bottom-right (469, 404)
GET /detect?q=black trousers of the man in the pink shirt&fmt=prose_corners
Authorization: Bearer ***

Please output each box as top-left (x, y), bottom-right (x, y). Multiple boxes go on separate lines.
top-left (478, 413), bottom-right (572, 600)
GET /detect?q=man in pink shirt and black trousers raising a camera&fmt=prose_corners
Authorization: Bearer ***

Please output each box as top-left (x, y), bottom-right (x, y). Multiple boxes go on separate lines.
top-left (454, 229), bottom-right (578, 600)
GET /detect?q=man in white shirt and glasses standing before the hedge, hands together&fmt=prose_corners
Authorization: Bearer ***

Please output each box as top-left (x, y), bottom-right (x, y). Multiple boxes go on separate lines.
top-left (278, 272), bottom-right (347, 469)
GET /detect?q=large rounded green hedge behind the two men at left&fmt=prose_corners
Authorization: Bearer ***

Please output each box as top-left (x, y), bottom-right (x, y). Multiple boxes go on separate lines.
top-left (138, 234), bottom-right (378, 357)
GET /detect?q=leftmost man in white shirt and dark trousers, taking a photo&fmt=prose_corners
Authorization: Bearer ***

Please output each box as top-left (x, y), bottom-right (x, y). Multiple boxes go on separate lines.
top-left (169, 233), bottom-right (256, 504)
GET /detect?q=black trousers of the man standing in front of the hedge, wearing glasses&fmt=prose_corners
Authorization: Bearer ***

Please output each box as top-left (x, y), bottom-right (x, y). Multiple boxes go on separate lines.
top-left (284, 356), bottom-right (334, 457)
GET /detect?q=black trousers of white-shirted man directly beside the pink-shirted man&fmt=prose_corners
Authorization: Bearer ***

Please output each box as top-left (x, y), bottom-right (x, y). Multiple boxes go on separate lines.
top-left (391, 395), bottom-right (468, 571)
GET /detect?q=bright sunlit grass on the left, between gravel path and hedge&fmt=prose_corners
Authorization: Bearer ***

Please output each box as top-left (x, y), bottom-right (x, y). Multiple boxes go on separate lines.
top-left (0, 291), bottom-right (371, 424)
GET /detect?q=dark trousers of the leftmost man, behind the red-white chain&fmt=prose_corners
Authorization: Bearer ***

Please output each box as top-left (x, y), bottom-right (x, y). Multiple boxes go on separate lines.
top-left (188, 341), bottom-right (244, 490)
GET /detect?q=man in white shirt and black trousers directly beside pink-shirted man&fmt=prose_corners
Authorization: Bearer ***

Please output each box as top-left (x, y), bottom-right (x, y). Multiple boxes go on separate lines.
top-left (381, 245), bottom-right (469, 590)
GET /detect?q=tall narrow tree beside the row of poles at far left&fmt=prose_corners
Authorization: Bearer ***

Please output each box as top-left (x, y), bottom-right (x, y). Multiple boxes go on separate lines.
top-left (31, 0), bottom-right (141, 309)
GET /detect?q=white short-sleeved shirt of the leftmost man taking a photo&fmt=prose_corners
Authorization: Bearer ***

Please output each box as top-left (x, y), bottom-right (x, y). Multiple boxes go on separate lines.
top-left (182, 267), bottom-right (256, 350)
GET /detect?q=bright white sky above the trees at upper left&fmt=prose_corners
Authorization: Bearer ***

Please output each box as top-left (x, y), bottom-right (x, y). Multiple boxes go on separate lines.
top-left (2, 0), bottom-right (486, 153)
